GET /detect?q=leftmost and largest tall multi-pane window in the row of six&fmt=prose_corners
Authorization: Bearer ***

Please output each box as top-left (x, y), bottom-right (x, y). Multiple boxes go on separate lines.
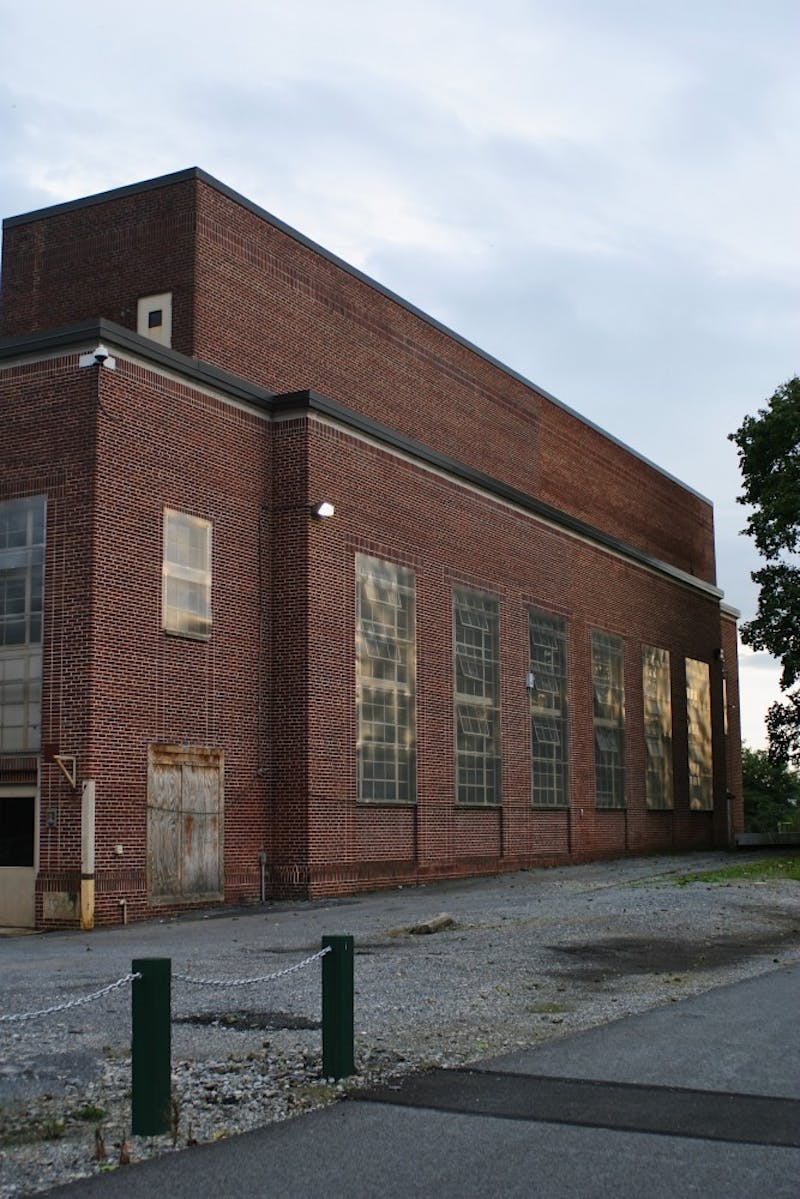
top-left (355, 554), bottom-right (416, 803)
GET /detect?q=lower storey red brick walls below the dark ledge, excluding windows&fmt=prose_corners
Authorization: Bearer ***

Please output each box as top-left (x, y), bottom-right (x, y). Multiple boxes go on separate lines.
top-left (0, 355), bottom-right (735, 923)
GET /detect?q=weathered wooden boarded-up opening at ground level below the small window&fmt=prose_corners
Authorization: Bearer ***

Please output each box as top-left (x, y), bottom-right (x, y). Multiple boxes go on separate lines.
top-left (148, 746), bottom-right (224, 903)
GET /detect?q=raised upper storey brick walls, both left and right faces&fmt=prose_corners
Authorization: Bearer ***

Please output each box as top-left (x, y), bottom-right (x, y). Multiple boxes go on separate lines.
top-left (0, 179), bottom-right (715, 582)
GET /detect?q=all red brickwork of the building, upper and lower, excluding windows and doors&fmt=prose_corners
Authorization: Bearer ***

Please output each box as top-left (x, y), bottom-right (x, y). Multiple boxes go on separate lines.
top-left (0, 175), bottom-right (741, 923)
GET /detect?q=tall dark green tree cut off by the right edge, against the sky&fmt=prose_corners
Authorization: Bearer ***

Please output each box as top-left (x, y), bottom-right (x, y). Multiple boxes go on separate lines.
top-left (730, 375), bottom-right (800, 764)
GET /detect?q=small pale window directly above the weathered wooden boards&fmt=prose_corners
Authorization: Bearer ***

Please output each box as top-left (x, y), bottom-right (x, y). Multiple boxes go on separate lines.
top-left (162, 508), bottom-right (211, 638)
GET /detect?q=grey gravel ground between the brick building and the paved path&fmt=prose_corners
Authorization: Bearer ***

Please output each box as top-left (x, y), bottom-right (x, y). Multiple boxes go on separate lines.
top-left (0, 852), bottom-right (800, 1199)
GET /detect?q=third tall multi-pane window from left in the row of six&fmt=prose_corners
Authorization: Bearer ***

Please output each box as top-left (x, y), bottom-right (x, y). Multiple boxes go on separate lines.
top-left (528, 611), bottom-right (567, 808)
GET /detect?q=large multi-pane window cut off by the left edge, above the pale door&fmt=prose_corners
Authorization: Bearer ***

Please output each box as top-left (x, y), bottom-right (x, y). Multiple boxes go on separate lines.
top-left (0, 495), bottom-right (46, 753)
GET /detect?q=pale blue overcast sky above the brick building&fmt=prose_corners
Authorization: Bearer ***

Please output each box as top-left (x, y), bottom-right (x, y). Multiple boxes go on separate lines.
top-left (0, 0), bottom-right (800, 746)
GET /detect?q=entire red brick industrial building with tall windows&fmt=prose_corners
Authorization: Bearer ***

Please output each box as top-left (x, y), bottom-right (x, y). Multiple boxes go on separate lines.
top-left (0, 169), bottom-right (741, 927)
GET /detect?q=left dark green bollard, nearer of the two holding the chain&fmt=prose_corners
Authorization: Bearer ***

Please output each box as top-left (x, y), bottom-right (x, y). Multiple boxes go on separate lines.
top-left (131, 958), bottom-right (172, 1137)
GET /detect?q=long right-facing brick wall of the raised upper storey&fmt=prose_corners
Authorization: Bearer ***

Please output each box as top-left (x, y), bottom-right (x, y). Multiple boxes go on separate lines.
top-left (194, 183), bottom-right (715, 582)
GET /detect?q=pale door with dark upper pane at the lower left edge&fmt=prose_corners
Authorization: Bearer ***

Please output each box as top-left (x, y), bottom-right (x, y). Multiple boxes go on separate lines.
top-left (0, 788), bottom-right (36, 928)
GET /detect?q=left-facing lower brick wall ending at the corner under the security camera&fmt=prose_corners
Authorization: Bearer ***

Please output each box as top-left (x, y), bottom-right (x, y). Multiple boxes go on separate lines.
top-left (0, 355), bottom-right (96, 923)
